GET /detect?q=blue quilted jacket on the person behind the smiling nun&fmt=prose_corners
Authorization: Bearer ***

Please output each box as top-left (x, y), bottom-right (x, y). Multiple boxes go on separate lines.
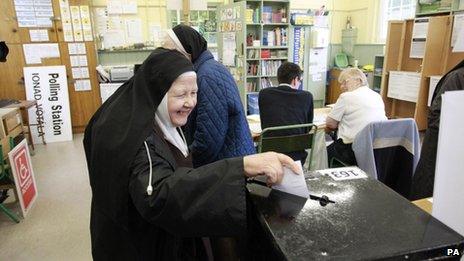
top-left (186, 51), bottom-right (256, 167)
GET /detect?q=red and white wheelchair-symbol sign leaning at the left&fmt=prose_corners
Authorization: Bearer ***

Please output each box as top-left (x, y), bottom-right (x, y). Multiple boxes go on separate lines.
top-left (8, 139), bottom-right (37, 217)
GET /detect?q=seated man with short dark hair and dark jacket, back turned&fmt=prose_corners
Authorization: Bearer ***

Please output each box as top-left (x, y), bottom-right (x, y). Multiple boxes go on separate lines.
top-left (258, 62), bottom-right (313, 164)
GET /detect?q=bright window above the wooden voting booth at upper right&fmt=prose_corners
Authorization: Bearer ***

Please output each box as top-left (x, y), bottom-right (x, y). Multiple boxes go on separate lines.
top-left (378, 0), bottom-right (417, 42)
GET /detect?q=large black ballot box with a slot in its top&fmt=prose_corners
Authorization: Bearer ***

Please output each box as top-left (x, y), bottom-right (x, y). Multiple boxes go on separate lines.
top-left (247, 169), bottom-right (464, 260)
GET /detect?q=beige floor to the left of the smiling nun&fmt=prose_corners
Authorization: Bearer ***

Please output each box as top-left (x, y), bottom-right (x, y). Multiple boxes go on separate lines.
top-left (0, 135), bottom-right (91, 260)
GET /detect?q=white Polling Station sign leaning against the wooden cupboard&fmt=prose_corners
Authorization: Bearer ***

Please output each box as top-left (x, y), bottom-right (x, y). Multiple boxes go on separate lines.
top-left (24, 66), bottom-right (72, 143)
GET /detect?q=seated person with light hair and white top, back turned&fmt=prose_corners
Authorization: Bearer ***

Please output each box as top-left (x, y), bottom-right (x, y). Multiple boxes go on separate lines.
top-left (326, 68), bottom-right (387, 165)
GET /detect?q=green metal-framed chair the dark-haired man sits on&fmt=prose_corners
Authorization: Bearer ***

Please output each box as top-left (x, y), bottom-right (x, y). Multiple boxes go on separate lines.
top-left (258, 123), bottom-right (317, 169)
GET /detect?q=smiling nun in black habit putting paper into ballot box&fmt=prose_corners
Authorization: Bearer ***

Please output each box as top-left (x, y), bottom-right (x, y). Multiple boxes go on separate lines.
top-left (84, 48), bottom-right (298, 260)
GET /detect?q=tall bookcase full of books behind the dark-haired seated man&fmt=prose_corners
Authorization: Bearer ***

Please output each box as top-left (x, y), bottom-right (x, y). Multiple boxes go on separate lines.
top-left (226, 0), bottom-right (291, 114)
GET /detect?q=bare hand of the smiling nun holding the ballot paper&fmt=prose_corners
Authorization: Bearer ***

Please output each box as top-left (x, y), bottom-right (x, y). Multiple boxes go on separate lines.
top-left (243, 152), bottom-right (303, 185)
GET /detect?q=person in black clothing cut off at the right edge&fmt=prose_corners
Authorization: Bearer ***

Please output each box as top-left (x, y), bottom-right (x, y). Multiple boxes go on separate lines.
top-left (411, 60), bottom-right (464, 200)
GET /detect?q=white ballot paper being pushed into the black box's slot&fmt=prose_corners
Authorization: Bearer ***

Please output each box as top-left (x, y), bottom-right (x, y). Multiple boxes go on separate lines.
top-left (272, 160), bottom-right (309, 198)
